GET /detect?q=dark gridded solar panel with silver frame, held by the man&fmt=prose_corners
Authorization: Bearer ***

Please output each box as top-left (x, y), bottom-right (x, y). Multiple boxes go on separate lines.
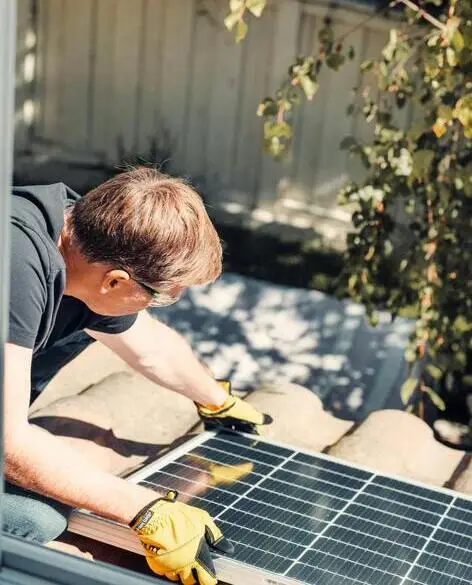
top-left (70, 432), bottom-right (472, 585)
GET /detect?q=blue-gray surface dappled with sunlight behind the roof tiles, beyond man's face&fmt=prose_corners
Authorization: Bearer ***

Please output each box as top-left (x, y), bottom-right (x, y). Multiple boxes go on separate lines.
top-left (153, 274), bottom-right (411, 419)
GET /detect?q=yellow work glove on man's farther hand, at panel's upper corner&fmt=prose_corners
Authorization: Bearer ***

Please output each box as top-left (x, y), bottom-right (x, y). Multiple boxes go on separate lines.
top-left (197, 380), bottom-right (272, 433)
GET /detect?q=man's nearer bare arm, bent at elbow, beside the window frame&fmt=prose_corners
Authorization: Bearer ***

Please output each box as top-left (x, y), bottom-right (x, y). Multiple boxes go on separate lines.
top-left (4, 343), bottom-right (159, 524)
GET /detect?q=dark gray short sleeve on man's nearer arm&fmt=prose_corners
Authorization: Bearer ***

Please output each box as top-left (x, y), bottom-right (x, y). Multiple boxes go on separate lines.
top-left (8, 225), bottom-right (47, 349)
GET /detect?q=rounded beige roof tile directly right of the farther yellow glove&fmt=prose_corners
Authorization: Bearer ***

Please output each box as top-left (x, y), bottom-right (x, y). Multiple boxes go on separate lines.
top-left (246, 384), bottom-right (353, 451)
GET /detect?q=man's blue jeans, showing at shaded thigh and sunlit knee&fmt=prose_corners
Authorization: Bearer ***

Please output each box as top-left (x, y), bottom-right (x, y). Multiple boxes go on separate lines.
top-left (2, 331), bottom-right (93, 543)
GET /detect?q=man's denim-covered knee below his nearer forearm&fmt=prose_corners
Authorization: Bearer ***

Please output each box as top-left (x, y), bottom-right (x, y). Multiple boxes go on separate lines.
top-left (2, 494), bottom-right (70, 544)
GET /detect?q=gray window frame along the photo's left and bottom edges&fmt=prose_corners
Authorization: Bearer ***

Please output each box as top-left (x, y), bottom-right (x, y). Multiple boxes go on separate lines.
top-left (0, 0), bottom-right (164, 585)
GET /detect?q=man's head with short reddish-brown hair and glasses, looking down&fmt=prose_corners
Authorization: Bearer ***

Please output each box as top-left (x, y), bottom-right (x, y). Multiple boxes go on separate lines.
top-left (63, 167), bottom-right (222, 315)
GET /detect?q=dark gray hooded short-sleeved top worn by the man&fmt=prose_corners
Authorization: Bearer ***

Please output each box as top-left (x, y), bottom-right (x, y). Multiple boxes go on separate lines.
top-left (8, 183), bottom-right (136, 353)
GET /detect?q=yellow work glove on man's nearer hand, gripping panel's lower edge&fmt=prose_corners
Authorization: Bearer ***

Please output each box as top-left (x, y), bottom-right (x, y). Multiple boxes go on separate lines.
top-left (130, 491), bottom-right (234, 585)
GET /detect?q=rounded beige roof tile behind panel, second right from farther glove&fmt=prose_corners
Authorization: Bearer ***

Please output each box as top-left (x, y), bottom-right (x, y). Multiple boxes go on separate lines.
top-left (329, 410), bottom-right (463, 486)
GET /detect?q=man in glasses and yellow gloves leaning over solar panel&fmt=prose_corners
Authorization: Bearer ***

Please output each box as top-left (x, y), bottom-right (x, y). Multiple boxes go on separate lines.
top-left (3, 168), bottom-right (270, 585)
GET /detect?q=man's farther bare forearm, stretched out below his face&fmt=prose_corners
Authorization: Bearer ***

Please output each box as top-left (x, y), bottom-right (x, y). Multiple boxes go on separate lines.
top-left (87, 311), bottom-right (228, 407)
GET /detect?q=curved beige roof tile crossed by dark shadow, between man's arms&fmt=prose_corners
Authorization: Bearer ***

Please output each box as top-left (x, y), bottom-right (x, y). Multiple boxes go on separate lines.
top-left (30, 373), bottom-right (198, 474)
